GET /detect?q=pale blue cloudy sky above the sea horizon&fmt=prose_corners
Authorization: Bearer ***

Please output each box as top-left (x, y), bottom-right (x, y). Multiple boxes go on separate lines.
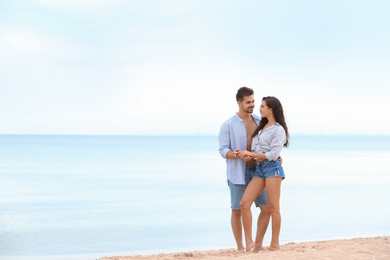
top-left (0, 0), bottom-right (390, 135)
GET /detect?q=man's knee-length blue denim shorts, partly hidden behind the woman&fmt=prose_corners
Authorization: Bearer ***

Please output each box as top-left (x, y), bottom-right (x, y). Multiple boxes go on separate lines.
top-left (228, 165), bottom-right (268, 210)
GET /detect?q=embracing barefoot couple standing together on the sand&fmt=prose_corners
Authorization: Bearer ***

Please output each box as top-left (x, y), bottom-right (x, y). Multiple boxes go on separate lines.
top-left (218, 87), bottom-right (289, 252)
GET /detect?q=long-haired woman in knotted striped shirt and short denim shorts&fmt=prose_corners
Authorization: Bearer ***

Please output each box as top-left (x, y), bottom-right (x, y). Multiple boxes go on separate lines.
top-left (236, 96), bottom-right (289, 252)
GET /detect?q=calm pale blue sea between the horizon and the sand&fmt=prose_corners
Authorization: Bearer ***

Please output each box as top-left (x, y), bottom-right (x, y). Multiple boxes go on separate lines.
top-left (0, 135), bottom-right (390, 260)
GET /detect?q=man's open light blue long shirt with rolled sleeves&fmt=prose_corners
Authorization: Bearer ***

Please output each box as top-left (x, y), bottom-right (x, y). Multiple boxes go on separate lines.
top-left (218, 114), bottom-right (261, 185)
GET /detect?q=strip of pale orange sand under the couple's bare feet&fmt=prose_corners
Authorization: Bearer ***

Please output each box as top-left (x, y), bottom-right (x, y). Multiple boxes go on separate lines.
top-left (99, 236), bottom-right (390, 260)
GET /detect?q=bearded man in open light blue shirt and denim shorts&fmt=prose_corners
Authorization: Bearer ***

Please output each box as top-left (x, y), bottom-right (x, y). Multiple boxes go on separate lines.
top-left (218, 87), bottom-right (271, 252)
